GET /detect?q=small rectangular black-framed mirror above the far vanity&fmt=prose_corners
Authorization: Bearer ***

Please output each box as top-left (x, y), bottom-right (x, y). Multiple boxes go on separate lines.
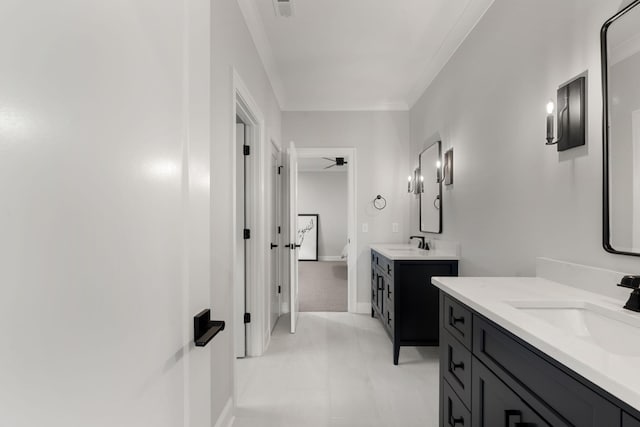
top-left (418, 141), bottom-right (442, 233)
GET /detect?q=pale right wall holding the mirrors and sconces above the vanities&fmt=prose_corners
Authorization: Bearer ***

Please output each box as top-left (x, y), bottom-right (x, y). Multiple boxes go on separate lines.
top-left (410, 0), bottom-right (640, 278)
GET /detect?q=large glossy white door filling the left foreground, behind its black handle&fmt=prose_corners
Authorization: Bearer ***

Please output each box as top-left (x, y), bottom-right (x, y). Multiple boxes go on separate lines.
top-left (0, 0), bottom-right (212, 427)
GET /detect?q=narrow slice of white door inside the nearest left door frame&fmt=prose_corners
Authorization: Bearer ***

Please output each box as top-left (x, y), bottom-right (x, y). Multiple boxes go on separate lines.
top-left (234, 118), bottom-right (247, 357)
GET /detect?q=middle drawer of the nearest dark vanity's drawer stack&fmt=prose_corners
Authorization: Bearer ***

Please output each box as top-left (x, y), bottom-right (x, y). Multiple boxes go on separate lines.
top-left (440, 331), bottom-right (471, 408)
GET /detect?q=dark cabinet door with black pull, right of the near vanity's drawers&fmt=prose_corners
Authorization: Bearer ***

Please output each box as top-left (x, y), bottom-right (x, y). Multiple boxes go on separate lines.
top-left (471, 358), bottom-right (561, 427)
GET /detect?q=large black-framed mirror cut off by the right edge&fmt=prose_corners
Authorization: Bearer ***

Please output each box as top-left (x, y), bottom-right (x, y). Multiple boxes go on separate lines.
top-left (600, 0), bottom-right (640, 256)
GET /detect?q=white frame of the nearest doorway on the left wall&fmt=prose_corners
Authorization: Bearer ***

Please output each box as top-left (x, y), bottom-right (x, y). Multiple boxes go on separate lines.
top-left (232, 67), bottom-right (270, 366)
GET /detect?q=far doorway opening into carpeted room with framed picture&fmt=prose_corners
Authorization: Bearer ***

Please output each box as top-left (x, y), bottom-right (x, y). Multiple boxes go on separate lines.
top-left (289, 148), bottom-right (358, 320)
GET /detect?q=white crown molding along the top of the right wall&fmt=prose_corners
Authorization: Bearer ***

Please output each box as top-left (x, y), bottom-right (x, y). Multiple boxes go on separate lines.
top-left (407, 0), bottom-right (494, 109)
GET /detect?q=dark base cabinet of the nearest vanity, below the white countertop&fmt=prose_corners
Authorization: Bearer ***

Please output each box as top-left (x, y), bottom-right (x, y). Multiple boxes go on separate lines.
top-left (440, 293), bottom-right (640, 427)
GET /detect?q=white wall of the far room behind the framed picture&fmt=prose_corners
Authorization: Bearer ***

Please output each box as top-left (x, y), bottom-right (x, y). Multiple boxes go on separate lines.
top-left (298, 171), bottom-right (347, 259)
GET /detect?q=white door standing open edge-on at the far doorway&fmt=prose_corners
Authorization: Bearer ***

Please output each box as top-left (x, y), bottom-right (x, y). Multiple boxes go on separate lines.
top-left (288, 142), bottom-right (298, 334)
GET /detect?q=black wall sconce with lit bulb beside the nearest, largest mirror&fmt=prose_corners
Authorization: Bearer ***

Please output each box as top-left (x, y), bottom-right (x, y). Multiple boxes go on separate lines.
top-left (545, 77), bottom-right (586, 151)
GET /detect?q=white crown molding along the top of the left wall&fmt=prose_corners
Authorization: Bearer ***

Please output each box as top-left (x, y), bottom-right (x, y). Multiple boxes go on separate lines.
top-left (237, 0), bottom-right (285, 109)
